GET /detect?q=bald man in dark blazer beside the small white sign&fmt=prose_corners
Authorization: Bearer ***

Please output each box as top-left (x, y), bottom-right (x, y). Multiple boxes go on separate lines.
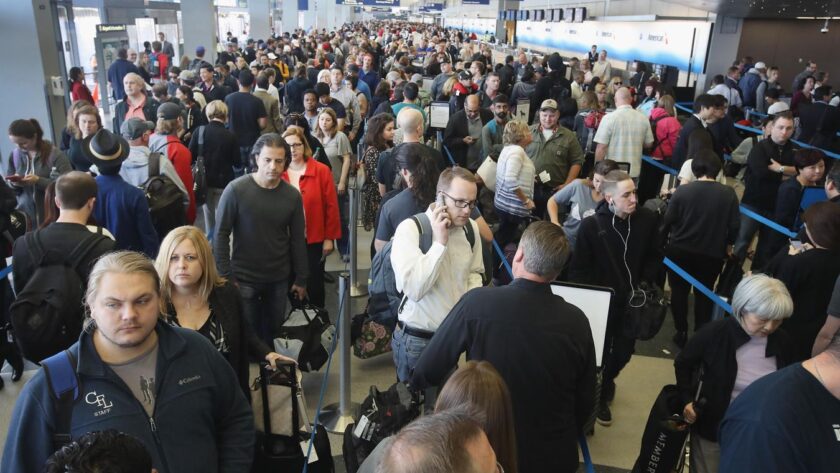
top-left (443, 94), bottom-right (493, 171)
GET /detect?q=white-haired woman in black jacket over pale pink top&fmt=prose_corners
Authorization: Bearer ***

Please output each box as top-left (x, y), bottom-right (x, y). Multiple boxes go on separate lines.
top-left (674, 274), bottom-right (793, 473)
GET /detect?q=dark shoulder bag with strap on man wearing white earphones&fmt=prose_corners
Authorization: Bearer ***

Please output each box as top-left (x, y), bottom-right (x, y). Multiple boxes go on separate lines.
top-left (592, 216), bottom-right (668, 340)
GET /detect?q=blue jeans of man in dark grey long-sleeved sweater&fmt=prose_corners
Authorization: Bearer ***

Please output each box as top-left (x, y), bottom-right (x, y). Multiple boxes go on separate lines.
top-left (239, 281), bottom-right (289, 347)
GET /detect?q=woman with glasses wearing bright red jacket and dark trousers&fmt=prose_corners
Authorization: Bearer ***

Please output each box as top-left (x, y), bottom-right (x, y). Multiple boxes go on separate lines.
top-left (283, 127), bottom-right (341, 307)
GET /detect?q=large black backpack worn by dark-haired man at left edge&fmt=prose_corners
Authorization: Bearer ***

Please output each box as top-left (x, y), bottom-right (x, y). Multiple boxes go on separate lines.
top-left (9, 231), bottom-right (103, 361)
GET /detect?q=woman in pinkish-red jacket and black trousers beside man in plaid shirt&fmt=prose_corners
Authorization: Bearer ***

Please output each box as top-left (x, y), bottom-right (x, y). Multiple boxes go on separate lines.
top-left (638, 95), bottom-right (681, 204)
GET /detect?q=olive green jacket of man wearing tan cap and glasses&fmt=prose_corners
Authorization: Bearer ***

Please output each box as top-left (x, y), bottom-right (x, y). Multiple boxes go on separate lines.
top-left (525, 123), bottom-right (584, 188)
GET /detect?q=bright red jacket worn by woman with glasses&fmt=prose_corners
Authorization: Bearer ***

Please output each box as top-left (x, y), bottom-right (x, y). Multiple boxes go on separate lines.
top-left (282, 158), bottom-right (341, 244)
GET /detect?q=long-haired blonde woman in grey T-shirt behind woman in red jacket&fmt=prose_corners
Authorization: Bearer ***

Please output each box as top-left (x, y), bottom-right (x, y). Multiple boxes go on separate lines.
top-left (315, 108), bottom-right (352, 261)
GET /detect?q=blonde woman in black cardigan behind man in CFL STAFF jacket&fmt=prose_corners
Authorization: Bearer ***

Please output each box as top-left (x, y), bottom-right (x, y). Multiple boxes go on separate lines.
top-left (155, 226), bottom-right (293, 398)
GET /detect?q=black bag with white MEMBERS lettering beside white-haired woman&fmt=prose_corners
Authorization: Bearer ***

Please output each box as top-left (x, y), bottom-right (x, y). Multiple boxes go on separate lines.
top-left (633, 384), bottom-right (690, 473)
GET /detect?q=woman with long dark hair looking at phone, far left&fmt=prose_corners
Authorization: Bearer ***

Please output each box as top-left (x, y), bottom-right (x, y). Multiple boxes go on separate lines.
top-left (5, 118), bottom-right (72, 225)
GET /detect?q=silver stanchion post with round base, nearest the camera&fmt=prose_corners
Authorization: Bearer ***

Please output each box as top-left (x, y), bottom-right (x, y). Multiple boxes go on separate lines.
top-left (321, 272), bottom-right (359, 434)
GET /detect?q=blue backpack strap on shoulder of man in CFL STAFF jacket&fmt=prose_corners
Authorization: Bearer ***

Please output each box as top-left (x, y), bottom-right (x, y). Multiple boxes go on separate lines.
top-left (41, 350), bottom-right (81, 450)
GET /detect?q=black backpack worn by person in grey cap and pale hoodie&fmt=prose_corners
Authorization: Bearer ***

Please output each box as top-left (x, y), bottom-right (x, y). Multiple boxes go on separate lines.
top-left (140, 153), bottom-right (187, 240)
